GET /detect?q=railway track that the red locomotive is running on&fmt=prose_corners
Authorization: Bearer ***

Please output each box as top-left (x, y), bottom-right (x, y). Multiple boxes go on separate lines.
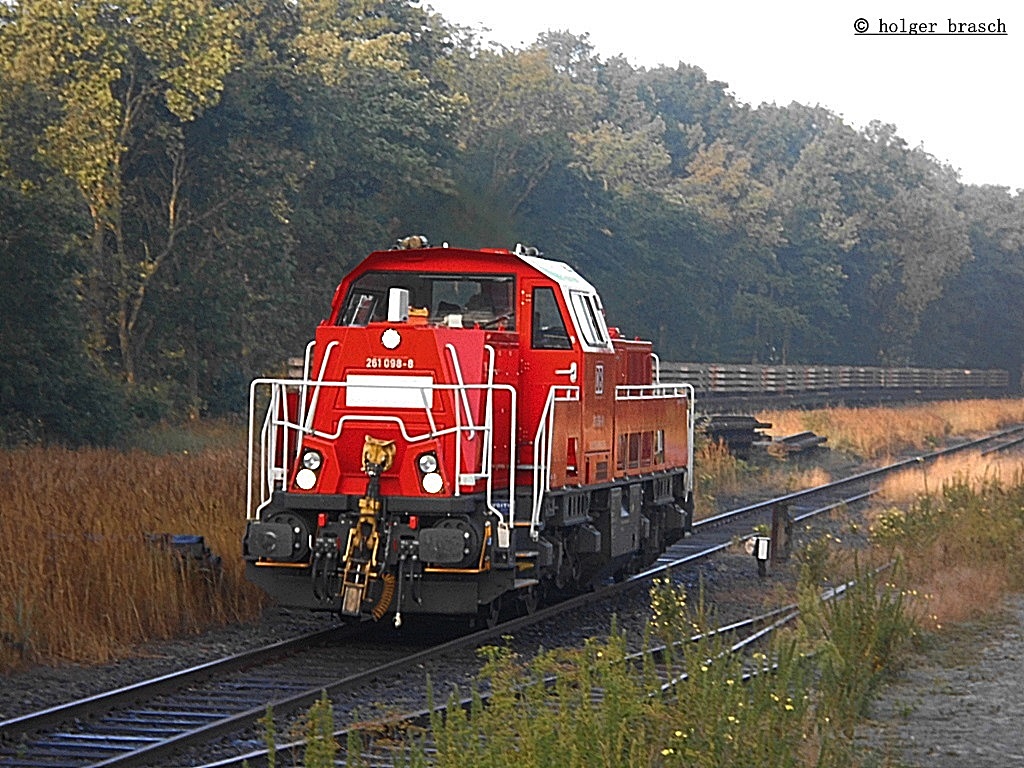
top-left (0, 427), bottom-right (1024, 768)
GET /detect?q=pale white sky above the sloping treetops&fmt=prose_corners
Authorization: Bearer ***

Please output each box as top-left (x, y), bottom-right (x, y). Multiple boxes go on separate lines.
top-left (424, 0), bottom-right (1024, 191)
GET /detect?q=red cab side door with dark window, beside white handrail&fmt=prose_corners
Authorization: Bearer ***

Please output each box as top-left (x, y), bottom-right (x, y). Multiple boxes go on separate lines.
top-left (519, 281), bottom-right (584, 487)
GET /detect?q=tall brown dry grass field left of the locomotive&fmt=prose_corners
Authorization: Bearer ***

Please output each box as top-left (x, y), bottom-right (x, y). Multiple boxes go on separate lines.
top-left (0, 439), bottom-right (262, 671)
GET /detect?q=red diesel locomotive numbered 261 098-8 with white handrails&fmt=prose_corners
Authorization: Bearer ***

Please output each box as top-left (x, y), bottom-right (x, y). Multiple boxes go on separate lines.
top-left (244, 237), bottom-right (693, 626)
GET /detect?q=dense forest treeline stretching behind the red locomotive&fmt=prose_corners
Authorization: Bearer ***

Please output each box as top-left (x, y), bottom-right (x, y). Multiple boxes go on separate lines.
top-left (0, 0), bottom-right (1024, 443)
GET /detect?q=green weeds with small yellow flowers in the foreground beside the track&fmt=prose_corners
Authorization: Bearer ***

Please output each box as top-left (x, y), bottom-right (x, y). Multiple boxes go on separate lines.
top-left (411, 573), bottom-right (912, 768)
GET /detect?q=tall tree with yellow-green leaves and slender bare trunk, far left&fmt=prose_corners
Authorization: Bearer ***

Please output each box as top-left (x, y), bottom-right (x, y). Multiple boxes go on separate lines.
top-left (0, 0), bottom-right (237, 383)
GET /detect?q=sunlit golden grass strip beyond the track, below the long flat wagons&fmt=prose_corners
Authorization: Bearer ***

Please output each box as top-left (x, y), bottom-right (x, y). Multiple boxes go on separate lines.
top-left (758, 399), bottom-right (1024, 459)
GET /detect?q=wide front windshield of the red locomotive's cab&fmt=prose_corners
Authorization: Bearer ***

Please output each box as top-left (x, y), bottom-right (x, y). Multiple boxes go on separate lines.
top-left (337, 271), bottom-right (516, 331)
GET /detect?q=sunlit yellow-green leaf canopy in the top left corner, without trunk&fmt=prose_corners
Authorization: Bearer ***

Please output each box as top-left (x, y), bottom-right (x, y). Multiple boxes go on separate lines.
top-left (0, 0), bottom-right (236, 227)
